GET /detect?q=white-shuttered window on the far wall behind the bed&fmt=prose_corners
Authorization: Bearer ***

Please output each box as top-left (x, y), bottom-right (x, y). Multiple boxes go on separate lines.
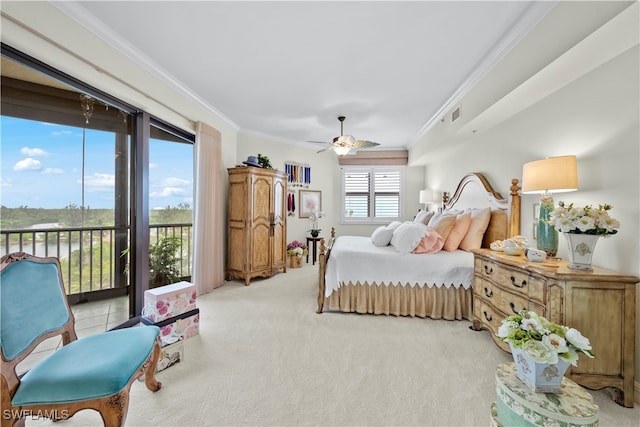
top-left (342, 167), bottom-right (403, 223)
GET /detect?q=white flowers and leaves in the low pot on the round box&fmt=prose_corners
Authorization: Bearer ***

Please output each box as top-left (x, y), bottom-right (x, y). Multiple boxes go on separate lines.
top-left (497, 310), bottom-right (595, 366)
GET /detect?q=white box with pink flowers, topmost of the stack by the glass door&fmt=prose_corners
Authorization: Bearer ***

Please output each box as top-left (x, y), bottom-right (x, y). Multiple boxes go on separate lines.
top-left (142, 282), bottom-right (197, 322)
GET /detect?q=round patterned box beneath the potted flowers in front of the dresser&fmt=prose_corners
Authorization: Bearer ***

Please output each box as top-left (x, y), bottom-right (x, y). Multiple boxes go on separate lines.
top-left (496, 363), bottom-right (600, 427)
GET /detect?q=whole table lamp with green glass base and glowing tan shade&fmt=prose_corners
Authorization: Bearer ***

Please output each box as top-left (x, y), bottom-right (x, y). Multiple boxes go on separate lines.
top-left (522, 156), bottom-right (578, 257)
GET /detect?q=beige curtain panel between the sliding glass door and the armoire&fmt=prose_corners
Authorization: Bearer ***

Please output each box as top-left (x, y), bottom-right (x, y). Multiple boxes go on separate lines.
top-left (192, 122), bottom-right (224, 294)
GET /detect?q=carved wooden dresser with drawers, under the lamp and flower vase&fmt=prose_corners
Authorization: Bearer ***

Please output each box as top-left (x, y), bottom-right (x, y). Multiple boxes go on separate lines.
top-left (472, 249), bottom-right (640, 407)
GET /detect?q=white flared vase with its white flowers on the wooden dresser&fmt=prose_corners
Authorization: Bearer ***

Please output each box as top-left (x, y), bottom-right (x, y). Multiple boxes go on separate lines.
top-left (549, 202), bottom-right (620, 270)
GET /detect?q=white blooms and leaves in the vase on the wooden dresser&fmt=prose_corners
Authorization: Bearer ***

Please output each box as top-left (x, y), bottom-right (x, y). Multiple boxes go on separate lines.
top-left (549, 202), bottom-right (620, 236)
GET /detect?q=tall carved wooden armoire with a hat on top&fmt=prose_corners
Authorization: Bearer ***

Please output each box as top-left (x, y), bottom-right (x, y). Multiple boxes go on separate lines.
top-left (227, 166), bottom-right (287, 286)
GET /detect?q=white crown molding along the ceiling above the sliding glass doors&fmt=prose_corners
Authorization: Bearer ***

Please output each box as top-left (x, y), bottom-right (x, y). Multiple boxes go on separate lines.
top-left (50, 1), bottom-right (240, 131)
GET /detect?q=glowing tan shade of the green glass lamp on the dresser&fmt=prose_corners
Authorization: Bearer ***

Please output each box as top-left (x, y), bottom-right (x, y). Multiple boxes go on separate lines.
top-left (522, 156), bottom-right (578, 194)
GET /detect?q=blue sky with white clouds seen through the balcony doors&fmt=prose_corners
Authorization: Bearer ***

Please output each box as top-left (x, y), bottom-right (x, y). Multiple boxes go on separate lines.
top-left (0, 116), bottom-right (193, 209)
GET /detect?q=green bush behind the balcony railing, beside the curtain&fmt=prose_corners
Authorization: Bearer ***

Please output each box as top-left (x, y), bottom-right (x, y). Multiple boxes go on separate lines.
top-left (149, 237), bottom-right (181, 288)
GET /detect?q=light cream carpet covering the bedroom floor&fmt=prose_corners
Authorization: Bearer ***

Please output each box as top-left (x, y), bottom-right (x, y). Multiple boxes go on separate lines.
top-left (27, 264), bottom-right (640, 427)
